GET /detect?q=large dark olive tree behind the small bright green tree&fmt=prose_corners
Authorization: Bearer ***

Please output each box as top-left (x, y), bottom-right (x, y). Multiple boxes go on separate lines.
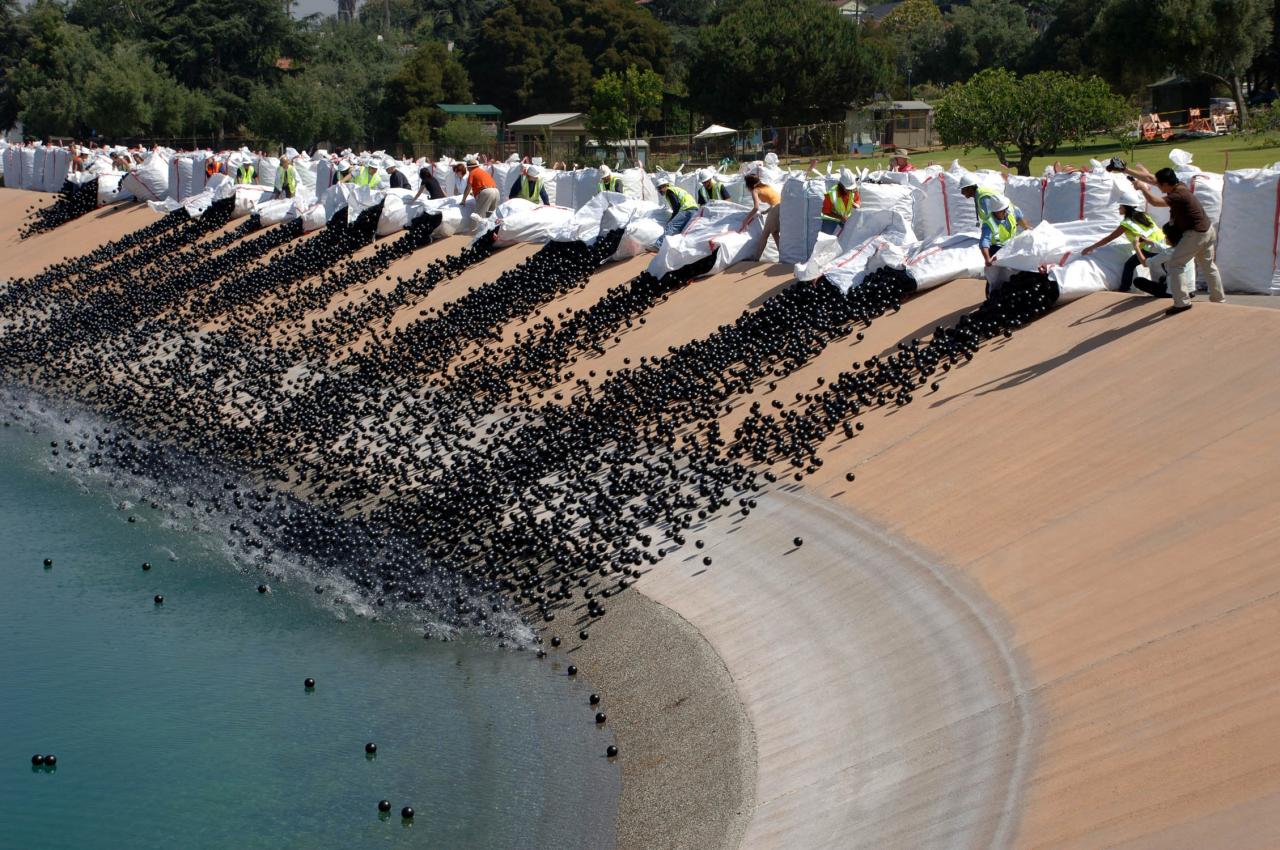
top-left (466, 0), bottom-right (671, 116)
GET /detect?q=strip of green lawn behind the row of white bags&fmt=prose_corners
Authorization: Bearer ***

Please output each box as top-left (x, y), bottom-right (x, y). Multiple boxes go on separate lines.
top-left (768, 136), bottom-right (1280, 175)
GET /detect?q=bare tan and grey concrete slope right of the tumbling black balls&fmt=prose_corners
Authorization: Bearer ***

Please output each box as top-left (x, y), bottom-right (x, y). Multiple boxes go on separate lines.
top-left (639, 282), bottom-right (1280, 849)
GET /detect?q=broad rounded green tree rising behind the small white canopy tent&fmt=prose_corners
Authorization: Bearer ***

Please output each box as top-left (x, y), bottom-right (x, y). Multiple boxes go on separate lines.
top-left (689, 0), bottom-right (890, 124)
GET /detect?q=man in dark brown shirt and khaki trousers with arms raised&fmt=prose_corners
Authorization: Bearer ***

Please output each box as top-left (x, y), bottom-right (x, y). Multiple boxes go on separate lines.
top-left (1138, 168), bottom-right (1226, 315)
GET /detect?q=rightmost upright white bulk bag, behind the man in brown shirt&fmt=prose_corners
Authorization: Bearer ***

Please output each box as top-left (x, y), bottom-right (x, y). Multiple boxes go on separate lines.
top-left (1217, 168), bottom-right (1280, 294)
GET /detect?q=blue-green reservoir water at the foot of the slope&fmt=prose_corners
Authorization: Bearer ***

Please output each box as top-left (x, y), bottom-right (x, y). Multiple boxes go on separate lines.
top-left (0, 419), bottom-right (620, 850)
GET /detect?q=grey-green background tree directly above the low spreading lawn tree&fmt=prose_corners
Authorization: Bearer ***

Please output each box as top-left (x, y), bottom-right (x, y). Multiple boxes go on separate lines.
top-left (925, 0), bottom-right (1036, 83)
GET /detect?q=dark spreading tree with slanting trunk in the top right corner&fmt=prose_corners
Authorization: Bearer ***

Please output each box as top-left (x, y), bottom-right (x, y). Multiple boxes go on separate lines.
top-left (1094, 0), bottom-right (1275, 123)
